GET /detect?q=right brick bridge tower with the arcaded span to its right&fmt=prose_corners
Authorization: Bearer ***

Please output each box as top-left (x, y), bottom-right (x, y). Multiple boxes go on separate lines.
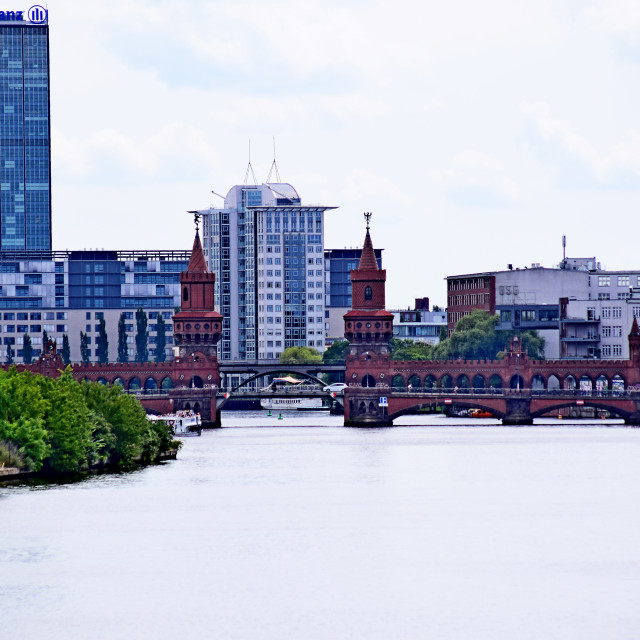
top-left (344, 222), bottom-right (640, 426)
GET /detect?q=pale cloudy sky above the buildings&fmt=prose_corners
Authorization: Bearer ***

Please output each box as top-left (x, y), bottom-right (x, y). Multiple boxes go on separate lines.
top-left (46, 0), bottom-right (640, 308)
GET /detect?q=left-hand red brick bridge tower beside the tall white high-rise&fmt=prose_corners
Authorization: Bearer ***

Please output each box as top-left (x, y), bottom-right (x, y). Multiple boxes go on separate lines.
top-left (171, 214), bottom-right (222, 425)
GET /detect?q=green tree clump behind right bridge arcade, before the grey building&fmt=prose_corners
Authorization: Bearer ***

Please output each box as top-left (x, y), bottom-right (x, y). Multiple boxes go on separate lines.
top-left (433, 309), bottom-right (544, 360)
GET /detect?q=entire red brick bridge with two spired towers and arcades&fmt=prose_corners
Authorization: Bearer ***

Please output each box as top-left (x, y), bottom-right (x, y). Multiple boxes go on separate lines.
top-left (10, 214), bottom-right (640, 427)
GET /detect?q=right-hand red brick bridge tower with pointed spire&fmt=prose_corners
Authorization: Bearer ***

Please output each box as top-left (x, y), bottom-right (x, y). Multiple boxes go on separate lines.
top-left (344, 213), bottom-right (393, 425)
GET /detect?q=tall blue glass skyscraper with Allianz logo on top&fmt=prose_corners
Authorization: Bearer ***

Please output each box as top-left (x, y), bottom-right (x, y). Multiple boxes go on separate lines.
top-left (0, 10), bottom-right (51, 251)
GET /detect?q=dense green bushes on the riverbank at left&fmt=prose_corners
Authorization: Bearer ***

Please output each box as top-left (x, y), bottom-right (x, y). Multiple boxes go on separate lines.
top-left (0, 367), bottom-right (173, 474)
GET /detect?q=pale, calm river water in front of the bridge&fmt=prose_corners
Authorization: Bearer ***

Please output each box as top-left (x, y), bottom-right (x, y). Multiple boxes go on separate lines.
top-left (0, 412), bottom-right (640, 640)
